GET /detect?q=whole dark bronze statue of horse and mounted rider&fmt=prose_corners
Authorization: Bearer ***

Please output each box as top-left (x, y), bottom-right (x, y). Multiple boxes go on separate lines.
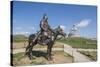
top-left (25, 14), bottom-right (66, 60)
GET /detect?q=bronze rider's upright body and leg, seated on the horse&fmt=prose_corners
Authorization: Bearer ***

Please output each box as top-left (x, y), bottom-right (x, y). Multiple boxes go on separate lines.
top-left (40, 14), bottom-right (53, 42)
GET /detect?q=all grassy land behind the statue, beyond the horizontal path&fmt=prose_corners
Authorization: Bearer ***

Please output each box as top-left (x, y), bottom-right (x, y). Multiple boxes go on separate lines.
top-left (12, 35), bottom-right (97, 49)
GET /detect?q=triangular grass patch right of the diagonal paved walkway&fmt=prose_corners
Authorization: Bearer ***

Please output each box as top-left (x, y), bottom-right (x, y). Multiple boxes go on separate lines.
top-left (79, 51), bottom-right (97, 61)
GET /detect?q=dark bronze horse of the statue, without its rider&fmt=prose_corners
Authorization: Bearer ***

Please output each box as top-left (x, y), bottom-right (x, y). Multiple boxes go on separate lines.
top-left (26, 26), bottom-right (66, 60)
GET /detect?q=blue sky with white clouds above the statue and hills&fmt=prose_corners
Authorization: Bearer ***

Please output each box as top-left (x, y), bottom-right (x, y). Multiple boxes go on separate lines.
top-left (11, 1), bottom-right (97, 37)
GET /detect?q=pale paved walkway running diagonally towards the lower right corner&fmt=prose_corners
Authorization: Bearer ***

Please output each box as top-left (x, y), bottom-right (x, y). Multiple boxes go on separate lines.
top-left (64, 44), bottom-right (91, 62)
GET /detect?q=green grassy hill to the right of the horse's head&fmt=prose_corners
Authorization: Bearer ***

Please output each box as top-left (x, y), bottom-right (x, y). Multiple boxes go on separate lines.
top-left (57, 37), bottom-right (97, 49)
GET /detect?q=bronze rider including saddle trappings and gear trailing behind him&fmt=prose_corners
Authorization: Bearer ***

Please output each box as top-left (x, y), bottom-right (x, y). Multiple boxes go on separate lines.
top-left (33, 14), bottom-right (54, 43)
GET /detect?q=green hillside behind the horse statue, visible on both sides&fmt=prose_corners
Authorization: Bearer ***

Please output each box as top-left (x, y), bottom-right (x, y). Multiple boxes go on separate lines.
top-left (12, 35), bottom-right (97, 49)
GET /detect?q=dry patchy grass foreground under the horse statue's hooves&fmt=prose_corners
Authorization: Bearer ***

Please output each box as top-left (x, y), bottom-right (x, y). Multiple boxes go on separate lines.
top-left (13, 51), bottom-right (73, 66)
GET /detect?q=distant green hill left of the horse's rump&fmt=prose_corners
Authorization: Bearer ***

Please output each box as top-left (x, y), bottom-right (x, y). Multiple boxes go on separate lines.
top-left (11, 34), bottom-right (28, 42)
